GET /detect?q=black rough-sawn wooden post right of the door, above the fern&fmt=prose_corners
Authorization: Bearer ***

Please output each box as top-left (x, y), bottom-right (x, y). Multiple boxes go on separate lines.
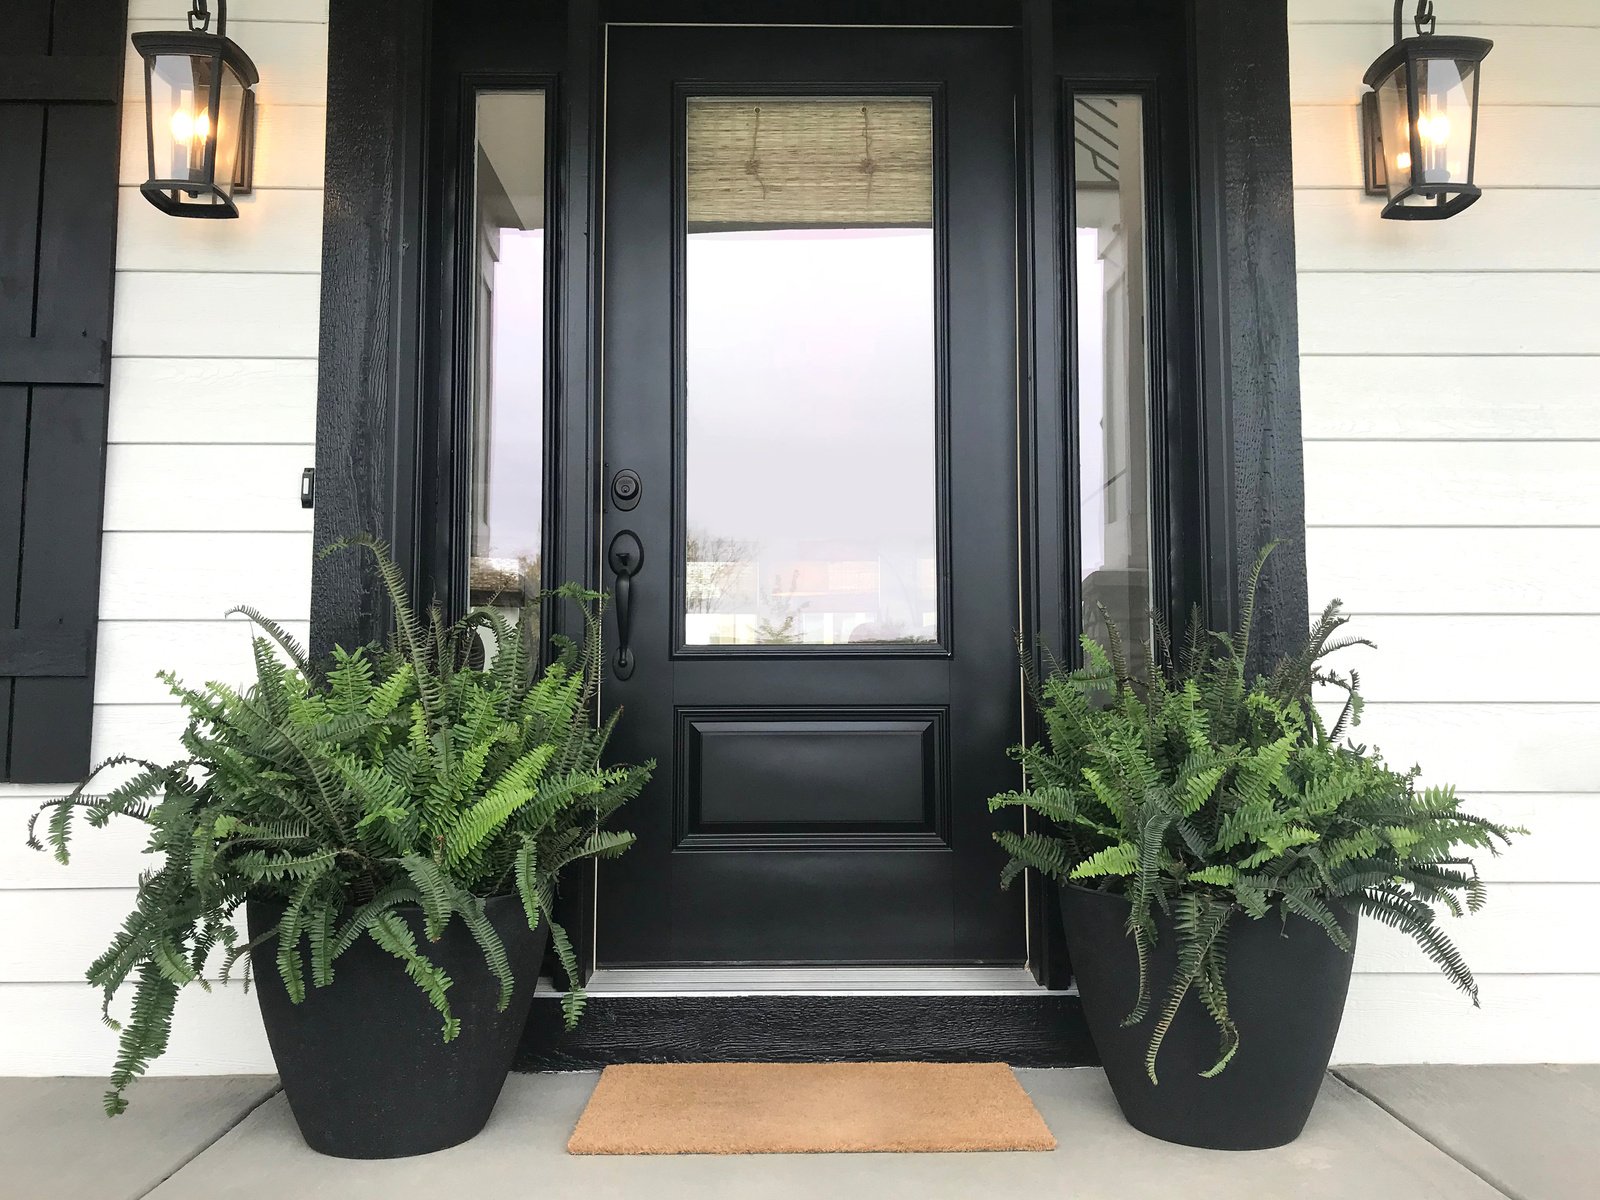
top-left (1192, 0), bottom-right (1305, 662)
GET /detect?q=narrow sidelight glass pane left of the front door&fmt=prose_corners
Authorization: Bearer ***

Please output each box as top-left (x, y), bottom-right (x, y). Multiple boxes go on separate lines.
top-left (469, 91), bottom-right (546, 659)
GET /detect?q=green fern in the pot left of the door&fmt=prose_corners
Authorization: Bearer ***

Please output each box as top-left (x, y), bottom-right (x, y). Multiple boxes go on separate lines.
top-left (29, 538), bottom-right (654, 1115)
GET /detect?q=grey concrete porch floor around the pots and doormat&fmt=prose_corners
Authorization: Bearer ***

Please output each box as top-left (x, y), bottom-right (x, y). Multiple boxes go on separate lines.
top-left (0, 1066), bottom-right (1600, 1200)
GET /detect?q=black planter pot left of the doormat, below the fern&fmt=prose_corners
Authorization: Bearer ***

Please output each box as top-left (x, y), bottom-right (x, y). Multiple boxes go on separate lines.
top-left (246, 896), bottom-right (549, 1158)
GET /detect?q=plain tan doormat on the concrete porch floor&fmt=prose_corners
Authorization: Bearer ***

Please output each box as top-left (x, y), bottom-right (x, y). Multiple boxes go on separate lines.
top-left (566, 1062), bottom-right (1056, 1154)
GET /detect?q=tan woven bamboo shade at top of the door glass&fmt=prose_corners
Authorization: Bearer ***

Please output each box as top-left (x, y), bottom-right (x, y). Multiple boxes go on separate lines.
top-left (686, 96), bottom-right (933, 234)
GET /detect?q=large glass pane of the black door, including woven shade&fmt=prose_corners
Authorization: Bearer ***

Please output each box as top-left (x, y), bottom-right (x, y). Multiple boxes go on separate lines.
top-left (683, 96), bottom-right (941, 646)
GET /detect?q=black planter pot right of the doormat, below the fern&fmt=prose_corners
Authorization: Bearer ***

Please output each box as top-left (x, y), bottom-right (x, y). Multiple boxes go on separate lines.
top-left (1061, 885), bottom-right (1357, 1150)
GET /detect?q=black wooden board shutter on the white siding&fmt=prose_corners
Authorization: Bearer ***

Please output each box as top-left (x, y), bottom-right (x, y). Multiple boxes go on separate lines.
top-left (0, 0), bottom-right (128, 782)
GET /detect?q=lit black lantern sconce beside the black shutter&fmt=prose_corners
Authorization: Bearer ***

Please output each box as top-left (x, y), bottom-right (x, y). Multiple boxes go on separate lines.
top-left (133, 0), bottom-right (261, 218)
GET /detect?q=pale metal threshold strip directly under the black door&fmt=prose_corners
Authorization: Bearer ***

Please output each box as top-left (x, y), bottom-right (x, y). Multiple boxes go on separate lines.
top-left (584, 966), bottom-right (1050, 997)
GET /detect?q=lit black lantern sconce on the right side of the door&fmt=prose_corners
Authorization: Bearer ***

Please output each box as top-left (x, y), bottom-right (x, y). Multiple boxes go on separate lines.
top-left (1362, 0), bottom-right (1494, 221)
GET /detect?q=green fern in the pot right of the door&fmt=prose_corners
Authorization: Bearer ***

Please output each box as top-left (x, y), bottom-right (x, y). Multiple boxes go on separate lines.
top-left (990, 547), bottom-right (1525, 1083)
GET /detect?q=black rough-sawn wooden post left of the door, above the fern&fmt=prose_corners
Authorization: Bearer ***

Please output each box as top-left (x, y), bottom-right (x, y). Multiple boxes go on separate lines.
top-left (310, 0), bottom-right (432, 654)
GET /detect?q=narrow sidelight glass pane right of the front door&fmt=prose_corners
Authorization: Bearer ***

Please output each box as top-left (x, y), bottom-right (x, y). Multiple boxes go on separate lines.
top-left (1072, 96), bottom-right (1152, 659)
